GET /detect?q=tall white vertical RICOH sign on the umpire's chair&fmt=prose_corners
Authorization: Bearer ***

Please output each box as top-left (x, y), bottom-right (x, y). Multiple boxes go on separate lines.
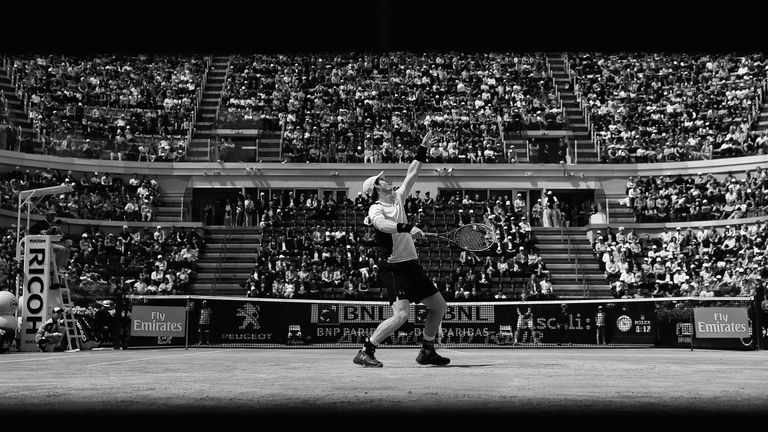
top-left (21, 235), bottom-right (51, 351)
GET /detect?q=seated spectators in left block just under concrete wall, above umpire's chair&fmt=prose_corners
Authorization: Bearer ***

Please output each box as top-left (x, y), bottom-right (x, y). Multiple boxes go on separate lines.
top-left (0, 168), bottom-right (162, 222)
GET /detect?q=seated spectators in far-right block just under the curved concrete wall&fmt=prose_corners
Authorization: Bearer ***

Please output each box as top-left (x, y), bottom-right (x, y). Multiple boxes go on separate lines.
top-left (623, 167), bottom-right (768, 222)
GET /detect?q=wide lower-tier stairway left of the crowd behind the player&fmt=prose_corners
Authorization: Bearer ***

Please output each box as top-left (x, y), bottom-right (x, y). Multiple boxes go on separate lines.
top-left (191, 226), bottom-right (262, 297)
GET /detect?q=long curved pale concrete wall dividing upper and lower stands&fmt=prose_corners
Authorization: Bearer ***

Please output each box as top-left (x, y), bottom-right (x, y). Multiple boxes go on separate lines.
top-left (0, 150), bottom-right (768, 204)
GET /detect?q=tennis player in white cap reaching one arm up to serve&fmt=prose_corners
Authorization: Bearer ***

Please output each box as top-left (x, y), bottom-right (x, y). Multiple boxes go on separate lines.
top-left (354, 131), bottom-right (450, 367)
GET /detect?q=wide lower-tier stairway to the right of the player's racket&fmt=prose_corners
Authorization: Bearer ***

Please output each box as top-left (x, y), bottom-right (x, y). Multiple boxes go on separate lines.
top-left (533, 227), bottom-right (611, 299)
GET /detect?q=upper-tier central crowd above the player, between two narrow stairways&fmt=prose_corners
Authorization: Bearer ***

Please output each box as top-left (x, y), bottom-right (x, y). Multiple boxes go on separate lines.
top-left (220, 52), bottom-right (563, 163)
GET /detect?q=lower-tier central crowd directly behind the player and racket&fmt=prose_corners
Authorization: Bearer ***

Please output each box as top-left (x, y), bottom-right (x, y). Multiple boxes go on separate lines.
top-left (225, 187), bottom-right (555, 301)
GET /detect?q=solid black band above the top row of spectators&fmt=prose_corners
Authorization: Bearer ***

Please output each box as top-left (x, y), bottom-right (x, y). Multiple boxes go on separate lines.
top-left (0, 0), bottom-right (765, 54)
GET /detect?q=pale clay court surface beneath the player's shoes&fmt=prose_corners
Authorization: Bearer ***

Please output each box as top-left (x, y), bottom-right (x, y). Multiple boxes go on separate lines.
top-left (0, 347), bottom-right (768, 424)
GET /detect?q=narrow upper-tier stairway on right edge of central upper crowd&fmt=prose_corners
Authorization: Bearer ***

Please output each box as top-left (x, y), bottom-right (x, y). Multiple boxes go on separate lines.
top-left (547, 53), bottom-right (598, 164)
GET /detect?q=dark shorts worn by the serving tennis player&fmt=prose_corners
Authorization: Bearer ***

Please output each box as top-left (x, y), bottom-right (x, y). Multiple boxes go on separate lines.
top-left (379, 260), bottom-right (440, 304)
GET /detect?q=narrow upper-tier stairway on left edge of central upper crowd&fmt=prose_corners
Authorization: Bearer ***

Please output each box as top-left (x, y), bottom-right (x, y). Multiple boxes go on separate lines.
top-left (186, 56), bottom-right (229, 162)
